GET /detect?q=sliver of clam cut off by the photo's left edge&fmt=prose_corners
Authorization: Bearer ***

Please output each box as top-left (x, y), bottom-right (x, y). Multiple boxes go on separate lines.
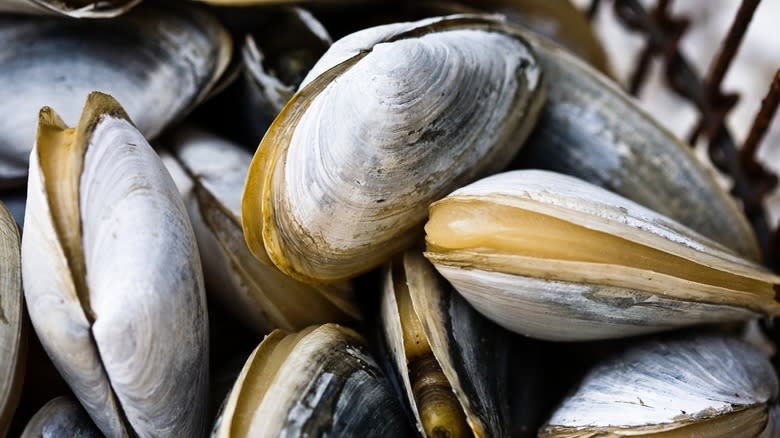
top-left (0, 203), bottom-right (27, 436)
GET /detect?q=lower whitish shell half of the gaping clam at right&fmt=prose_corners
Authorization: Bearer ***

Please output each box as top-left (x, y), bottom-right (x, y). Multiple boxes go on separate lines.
top-left (437, 265), bottom-right (759, 341)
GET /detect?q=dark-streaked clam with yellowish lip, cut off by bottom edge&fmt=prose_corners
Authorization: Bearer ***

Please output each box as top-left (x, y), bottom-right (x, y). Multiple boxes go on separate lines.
top-left (212, 324), bottom-right (410, 438)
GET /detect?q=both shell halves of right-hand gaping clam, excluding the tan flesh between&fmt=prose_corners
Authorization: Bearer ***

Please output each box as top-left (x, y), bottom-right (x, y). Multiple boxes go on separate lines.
top-left (425, 170), bottom-right (780, 340)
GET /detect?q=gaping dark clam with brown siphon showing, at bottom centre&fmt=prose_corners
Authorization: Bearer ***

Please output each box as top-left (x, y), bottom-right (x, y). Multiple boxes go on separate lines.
top-left (381, 251), bottom-right (530, 437)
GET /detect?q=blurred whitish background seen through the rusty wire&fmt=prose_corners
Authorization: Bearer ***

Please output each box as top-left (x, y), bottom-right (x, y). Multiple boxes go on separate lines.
top-left (572, 0), bottom-right (780, 224)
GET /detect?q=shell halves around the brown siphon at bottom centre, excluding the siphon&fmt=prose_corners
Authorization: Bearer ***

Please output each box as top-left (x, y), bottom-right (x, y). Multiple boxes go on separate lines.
top-left (381, 251), bottom-right (511, 437)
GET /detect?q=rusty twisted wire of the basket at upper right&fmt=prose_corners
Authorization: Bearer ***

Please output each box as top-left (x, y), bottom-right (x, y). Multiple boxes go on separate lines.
top-left (589, 0), bottom-right (780, 270)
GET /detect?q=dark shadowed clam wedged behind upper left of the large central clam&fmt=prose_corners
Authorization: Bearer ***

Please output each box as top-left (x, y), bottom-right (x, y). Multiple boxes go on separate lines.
top-left (194, 6), bottom-right (333, 150)
